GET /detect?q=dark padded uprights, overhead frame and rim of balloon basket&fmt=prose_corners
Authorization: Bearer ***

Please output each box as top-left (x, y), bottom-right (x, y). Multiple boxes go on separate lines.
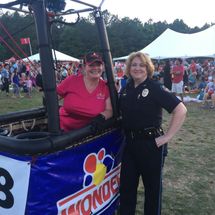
top-left (0, 0), bottom-right (118, 155)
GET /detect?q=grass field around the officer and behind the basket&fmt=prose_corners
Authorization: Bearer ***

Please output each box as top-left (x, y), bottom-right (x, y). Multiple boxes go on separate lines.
top-left (0, 91), bottom-right (215, 215)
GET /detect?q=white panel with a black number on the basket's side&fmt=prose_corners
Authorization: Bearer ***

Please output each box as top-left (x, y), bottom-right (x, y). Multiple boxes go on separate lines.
top-left (0, 155), bottom-right (31, 215)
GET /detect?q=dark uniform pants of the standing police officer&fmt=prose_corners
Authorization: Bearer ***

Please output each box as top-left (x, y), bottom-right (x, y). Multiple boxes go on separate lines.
top-left (120, 135), bottom-right (163, 215)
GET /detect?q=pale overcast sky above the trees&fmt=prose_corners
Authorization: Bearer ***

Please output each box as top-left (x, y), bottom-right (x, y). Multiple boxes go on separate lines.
top-left (0, 0), bottom-right (215, 27)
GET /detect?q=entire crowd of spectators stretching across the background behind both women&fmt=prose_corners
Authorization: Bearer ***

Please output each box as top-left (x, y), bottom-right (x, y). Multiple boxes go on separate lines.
top-left (0, 55), bottom-right (215, 105)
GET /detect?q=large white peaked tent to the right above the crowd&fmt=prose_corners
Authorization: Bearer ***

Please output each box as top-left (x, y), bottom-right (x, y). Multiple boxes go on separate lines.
top-left (114, 25), bottom-right (215, 60)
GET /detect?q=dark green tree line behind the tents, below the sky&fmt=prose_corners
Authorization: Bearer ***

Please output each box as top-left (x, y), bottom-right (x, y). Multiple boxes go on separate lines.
top-left (0, 10), bottom-right (214, 61)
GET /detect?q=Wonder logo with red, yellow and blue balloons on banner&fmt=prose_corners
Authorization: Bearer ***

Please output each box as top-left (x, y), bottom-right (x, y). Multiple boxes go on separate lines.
top-left (57, 148), bottom-right (120, 215)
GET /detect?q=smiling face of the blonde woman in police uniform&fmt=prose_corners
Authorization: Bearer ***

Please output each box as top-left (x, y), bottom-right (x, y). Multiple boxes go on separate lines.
top-left (130, 57), bottom-right (147, 83)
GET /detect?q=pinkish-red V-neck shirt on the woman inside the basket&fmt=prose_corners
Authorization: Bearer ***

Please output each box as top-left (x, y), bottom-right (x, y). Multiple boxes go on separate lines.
top-left (57, 75), bottom-right (109, 131)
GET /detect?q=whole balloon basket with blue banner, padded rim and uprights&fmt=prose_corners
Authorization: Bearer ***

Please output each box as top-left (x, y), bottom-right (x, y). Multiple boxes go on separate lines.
top-left (0, 0), bottom-right (124, 215)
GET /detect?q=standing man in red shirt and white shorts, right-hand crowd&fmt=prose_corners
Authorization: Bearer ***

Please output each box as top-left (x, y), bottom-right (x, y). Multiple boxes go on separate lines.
top-left (170, 58), bottom-right (184, 102)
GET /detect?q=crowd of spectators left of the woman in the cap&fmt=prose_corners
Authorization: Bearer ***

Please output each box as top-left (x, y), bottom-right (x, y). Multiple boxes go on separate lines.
top-left (0, 59), bottom-right (82, 98)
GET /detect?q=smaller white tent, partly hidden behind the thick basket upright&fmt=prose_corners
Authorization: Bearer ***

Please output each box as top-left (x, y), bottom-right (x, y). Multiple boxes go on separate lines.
top-left (23, 49), bottom-right (80, 62)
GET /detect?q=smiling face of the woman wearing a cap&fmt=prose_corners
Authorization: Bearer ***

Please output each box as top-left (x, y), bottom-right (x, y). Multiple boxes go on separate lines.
top-left (85, 62), bottom-right (103, 79)
